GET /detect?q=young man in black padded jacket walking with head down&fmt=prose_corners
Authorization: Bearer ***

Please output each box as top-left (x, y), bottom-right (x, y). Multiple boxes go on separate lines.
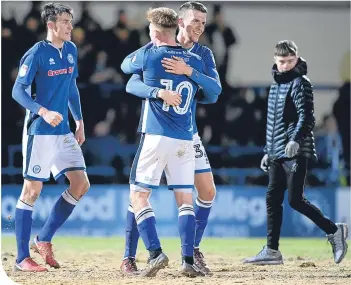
top-left (244, 41), bottom-right (348, 264)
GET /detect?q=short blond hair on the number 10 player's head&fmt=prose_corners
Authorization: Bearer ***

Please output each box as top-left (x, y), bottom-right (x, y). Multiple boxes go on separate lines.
top-left (146, 7), bottom-right (178, 29)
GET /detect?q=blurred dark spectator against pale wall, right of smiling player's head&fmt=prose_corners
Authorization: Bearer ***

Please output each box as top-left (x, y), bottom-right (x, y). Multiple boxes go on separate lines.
top-left (206, 4), bottom-right (237, 84)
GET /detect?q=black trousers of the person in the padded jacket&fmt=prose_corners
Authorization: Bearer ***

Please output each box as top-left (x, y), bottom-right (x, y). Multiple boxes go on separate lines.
top-left (266, 157), bottom-right (337, 250)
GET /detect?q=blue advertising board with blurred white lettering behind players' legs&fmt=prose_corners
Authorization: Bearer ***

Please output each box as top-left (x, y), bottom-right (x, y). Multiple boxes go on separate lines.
top-left (1, 185), bottom-right (350, 237)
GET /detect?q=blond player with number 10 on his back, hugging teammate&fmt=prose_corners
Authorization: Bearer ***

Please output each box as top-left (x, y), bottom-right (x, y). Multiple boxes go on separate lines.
top-left (123, 7), bottom-right (209, 277)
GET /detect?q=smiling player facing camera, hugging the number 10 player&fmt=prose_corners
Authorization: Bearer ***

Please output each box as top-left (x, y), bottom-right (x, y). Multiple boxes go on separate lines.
top-left (121, 2), bottom-right (222, 274)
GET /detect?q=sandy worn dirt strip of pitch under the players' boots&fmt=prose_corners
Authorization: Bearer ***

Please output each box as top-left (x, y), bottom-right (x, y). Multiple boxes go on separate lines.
top-left (2, 250), bottom-right (351, 285)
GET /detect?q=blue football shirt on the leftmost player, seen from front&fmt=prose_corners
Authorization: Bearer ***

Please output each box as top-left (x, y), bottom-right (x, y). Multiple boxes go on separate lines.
top-left (16, 40), bottom-right (78, 135)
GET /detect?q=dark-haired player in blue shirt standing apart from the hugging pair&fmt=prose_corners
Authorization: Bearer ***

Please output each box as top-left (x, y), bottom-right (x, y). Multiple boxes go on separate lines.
top-left (12, 3), bottom-right (90, 272)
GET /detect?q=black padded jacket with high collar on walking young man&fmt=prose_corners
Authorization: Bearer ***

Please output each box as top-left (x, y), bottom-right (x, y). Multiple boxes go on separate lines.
top-left (264, 58), bottom-right (317, 160)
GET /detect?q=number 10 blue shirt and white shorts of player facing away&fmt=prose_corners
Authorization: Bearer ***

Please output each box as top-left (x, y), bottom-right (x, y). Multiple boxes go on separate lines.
top-left (124, 33), bottom-right (204, 189)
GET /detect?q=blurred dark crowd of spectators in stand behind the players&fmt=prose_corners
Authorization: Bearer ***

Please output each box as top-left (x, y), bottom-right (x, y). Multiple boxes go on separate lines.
top-left (1, 2), bottom-right (350, 186)
